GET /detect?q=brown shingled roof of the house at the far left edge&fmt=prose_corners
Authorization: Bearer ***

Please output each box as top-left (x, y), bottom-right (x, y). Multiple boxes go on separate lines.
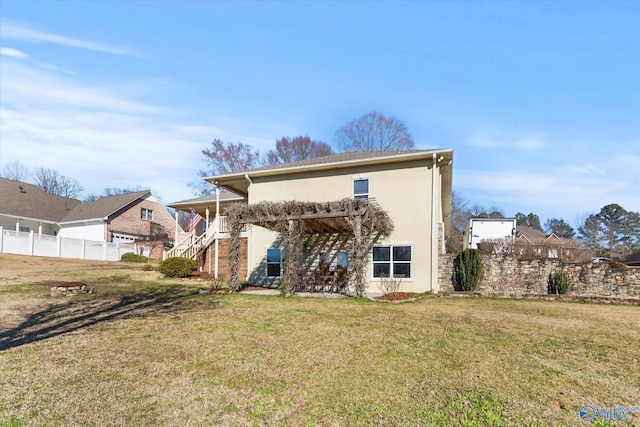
top-left (0, 178), bottom-right (81, 222)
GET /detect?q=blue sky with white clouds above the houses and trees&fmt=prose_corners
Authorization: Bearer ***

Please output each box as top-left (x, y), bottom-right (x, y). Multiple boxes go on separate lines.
top-left (0, 0), bottom-right (640, 225)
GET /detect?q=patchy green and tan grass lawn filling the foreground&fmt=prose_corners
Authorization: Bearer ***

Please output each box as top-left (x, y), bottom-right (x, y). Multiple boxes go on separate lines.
top-left (0, 256), bottom-right (640, 426)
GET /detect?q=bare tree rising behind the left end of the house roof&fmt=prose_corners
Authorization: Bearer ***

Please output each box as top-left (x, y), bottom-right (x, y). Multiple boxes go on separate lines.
top-left (189, 138), bottom-right (260, 196)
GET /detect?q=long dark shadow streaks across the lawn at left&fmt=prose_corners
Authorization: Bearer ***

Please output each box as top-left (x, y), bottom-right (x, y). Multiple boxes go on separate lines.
top-left (0, 287), bottom-right (215, 351)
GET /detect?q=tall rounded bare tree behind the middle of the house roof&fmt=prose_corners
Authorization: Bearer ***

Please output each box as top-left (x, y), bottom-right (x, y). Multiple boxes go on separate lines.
top-left (335, 111), bottom-right (413, 152)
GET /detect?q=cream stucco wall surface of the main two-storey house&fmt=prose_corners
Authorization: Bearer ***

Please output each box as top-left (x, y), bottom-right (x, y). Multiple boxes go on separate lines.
top-left (249, 160), bottom-right (442, 294)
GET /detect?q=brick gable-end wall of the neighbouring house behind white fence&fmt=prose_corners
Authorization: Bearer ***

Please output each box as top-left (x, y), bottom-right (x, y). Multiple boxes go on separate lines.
top-left (107, 200), bottom-right (176, 241)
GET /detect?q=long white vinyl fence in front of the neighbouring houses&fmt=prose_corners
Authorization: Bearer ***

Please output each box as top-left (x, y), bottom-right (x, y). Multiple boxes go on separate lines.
top-left (0, 227), bottom-right (136, 261)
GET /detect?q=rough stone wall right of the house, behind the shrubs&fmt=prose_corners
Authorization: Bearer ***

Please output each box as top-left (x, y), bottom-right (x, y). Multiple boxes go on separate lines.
top-left (438, 254), bottom-right (640, 299)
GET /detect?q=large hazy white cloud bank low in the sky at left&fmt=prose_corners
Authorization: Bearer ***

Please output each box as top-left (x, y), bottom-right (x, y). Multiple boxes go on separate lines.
top-left (0, 59), bottom-right (284, 202)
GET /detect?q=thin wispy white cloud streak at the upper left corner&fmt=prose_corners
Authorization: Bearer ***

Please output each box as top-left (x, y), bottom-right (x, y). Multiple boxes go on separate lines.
top-left (0, 21), bottom-right (137, 56)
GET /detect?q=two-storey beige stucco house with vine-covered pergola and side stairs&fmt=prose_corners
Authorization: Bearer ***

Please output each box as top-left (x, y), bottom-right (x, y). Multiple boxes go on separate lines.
top-left (169, 149), bottom-right (453, 295)
